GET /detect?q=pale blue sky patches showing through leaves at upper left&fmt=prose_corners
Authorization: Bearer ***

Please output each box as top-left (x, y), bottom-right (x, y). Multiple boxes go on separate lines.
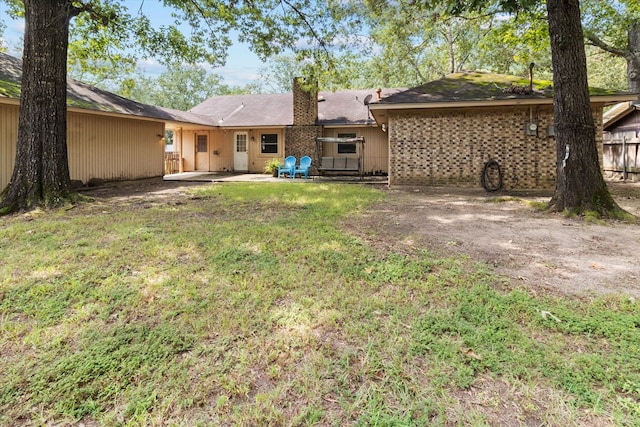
top-left (0, 0), bottom-right (265, 86)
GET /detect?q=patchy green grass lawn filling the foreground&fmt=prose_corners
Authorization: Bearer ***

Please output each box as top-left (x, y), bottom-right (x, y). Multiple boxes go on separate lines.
top-left (0, 182), bottom-right (640, 426)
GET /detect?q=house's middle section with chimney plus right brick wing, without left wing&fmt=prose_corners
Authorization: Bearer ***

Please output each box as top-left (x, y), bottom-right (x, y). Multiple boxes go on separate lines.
top-left (179, 72), bottom-right (635, 189)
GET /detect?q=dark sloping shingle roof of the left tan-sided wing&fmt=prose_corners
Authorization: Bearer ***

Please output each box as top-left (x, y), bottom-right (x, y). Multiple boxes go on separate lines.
top-left (0, 53), bottom-right (218, 125)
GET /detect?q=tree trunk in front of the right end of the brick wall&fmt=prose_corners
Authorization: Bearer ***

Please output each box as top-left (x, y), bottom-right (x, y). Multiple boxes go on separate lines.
top-left (547, 0), bottom-right (620, 216)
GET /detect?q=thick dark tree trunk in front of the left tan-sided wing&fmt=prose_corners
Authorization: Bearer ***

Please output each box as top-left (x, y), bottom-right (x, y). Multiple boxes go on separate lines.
top-left (0, 0), bottom-right (72, 213)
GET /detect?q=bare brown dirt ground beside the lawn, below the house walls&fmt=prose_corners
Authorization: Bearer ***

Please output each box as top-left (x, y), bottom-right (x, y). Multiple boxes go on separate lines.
top-left (85, 179), bottom-right (640, 298)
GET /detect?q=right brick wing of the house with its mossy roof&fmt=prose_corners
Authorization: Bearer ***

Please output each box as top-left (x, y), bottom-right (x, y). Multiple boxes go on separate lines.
top-left (370, 72), bottom-right (636, 189)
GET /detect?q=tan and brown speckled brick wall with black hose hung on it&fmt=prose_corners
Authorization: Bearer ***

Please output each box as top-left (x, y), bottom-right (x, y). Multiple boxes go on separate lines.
top-left (389, 106), bottom-right (602, 189)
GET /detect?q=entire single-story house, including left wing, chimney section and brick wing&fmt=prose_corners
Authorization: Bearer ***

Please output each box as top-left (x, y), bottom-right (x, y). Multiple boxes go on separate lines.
top-left (0, 54), bottom-right (637, 189)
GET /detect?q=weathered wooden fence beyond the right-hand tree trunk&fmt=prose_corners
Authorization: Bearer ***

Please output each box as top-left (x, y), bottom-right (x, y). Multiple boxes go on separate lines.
top-left (602, 137), bottom-right (640, 181)
